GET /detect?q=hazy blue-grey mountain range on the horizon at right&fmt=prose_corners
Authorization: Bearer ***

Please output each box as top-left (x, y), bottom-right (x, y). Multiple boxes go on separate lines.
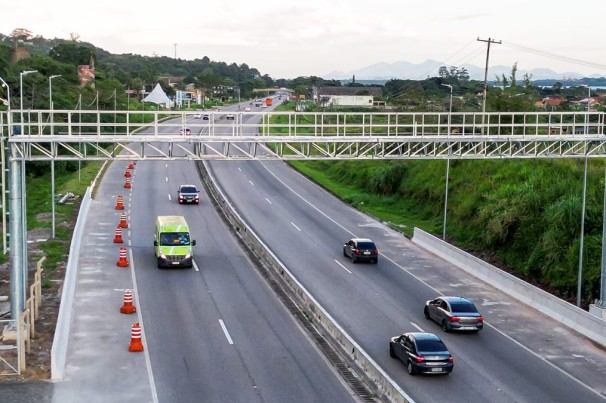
top-left (322, 60), bottom-right (603, 81)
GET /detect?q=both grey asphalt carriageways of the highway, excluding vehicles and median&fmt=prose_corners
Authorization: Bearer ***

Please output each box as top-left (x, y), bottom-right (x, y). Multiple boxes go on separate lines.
top-left (45, 98), bottom-right (606, 402)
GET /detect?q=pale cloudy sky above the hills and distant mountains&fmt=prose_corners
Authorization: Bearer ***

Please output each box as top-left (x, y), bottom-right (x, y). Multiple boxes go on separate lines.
top-left (0, 0), bottom-right (606, 79)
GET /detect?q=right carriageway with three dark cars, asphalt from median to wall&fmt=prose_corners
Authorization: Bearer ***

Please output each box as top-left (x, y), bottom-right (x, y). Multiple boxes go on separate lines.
top-left (198, 97), bottom-right (606, 402)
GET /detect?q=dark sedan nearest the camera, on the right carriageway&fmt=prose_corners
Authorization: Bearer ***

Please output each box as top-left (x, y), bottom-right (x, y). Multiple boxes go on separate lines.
top-left (389, 332), bottom-right (454, 375)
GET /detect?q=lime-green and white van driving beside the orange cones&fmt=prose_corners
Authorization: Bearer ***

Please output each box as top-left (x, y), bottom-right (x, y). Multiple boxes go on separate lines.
top-left (154, 216), bottom-right (196, 268)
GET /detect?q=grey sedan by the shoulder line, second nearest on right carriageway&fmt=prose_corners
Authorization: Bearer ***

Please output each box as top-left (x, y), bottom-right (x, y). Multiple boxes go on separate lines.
top-left (423, 297), bottom-right (484, 332)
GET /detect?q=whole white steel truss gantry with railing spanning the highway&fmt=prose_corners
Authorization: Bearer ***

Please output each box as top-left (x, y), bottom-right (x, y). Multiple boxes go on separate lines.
top-left (0, 110), bottom-right (606, 161)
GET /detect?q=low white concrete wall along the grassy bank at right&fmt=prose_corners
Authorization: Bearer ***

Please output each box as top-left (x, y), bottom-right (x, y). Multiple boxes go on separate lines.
top-left (412, 228), bottom-right (606, 346)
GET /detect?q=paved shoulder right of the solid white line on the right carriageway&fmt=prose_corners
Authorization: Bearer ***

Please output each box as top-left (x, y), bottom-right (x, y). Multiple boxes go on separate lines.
top-left (222, 161), bottom-right (606, 395)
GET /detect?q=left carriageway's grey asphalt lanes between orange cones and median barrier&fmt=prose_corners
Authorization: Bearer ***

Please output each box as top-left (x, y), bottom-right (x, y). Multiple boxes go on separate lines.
top-left (128, 162), bottom-right (352, 401)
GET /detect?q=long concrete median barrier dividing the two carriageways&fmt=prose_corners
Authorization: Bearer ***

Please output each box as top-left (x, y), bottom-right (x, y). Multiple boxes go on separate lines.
top-left (198, 164), bottom-right (413, 402)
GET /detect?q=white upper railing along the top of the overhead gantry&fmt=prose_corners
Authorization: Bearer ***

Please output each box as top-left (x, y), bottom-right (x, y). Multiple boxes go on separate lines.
top-left (0, 110), bottom-right (605, 137)
